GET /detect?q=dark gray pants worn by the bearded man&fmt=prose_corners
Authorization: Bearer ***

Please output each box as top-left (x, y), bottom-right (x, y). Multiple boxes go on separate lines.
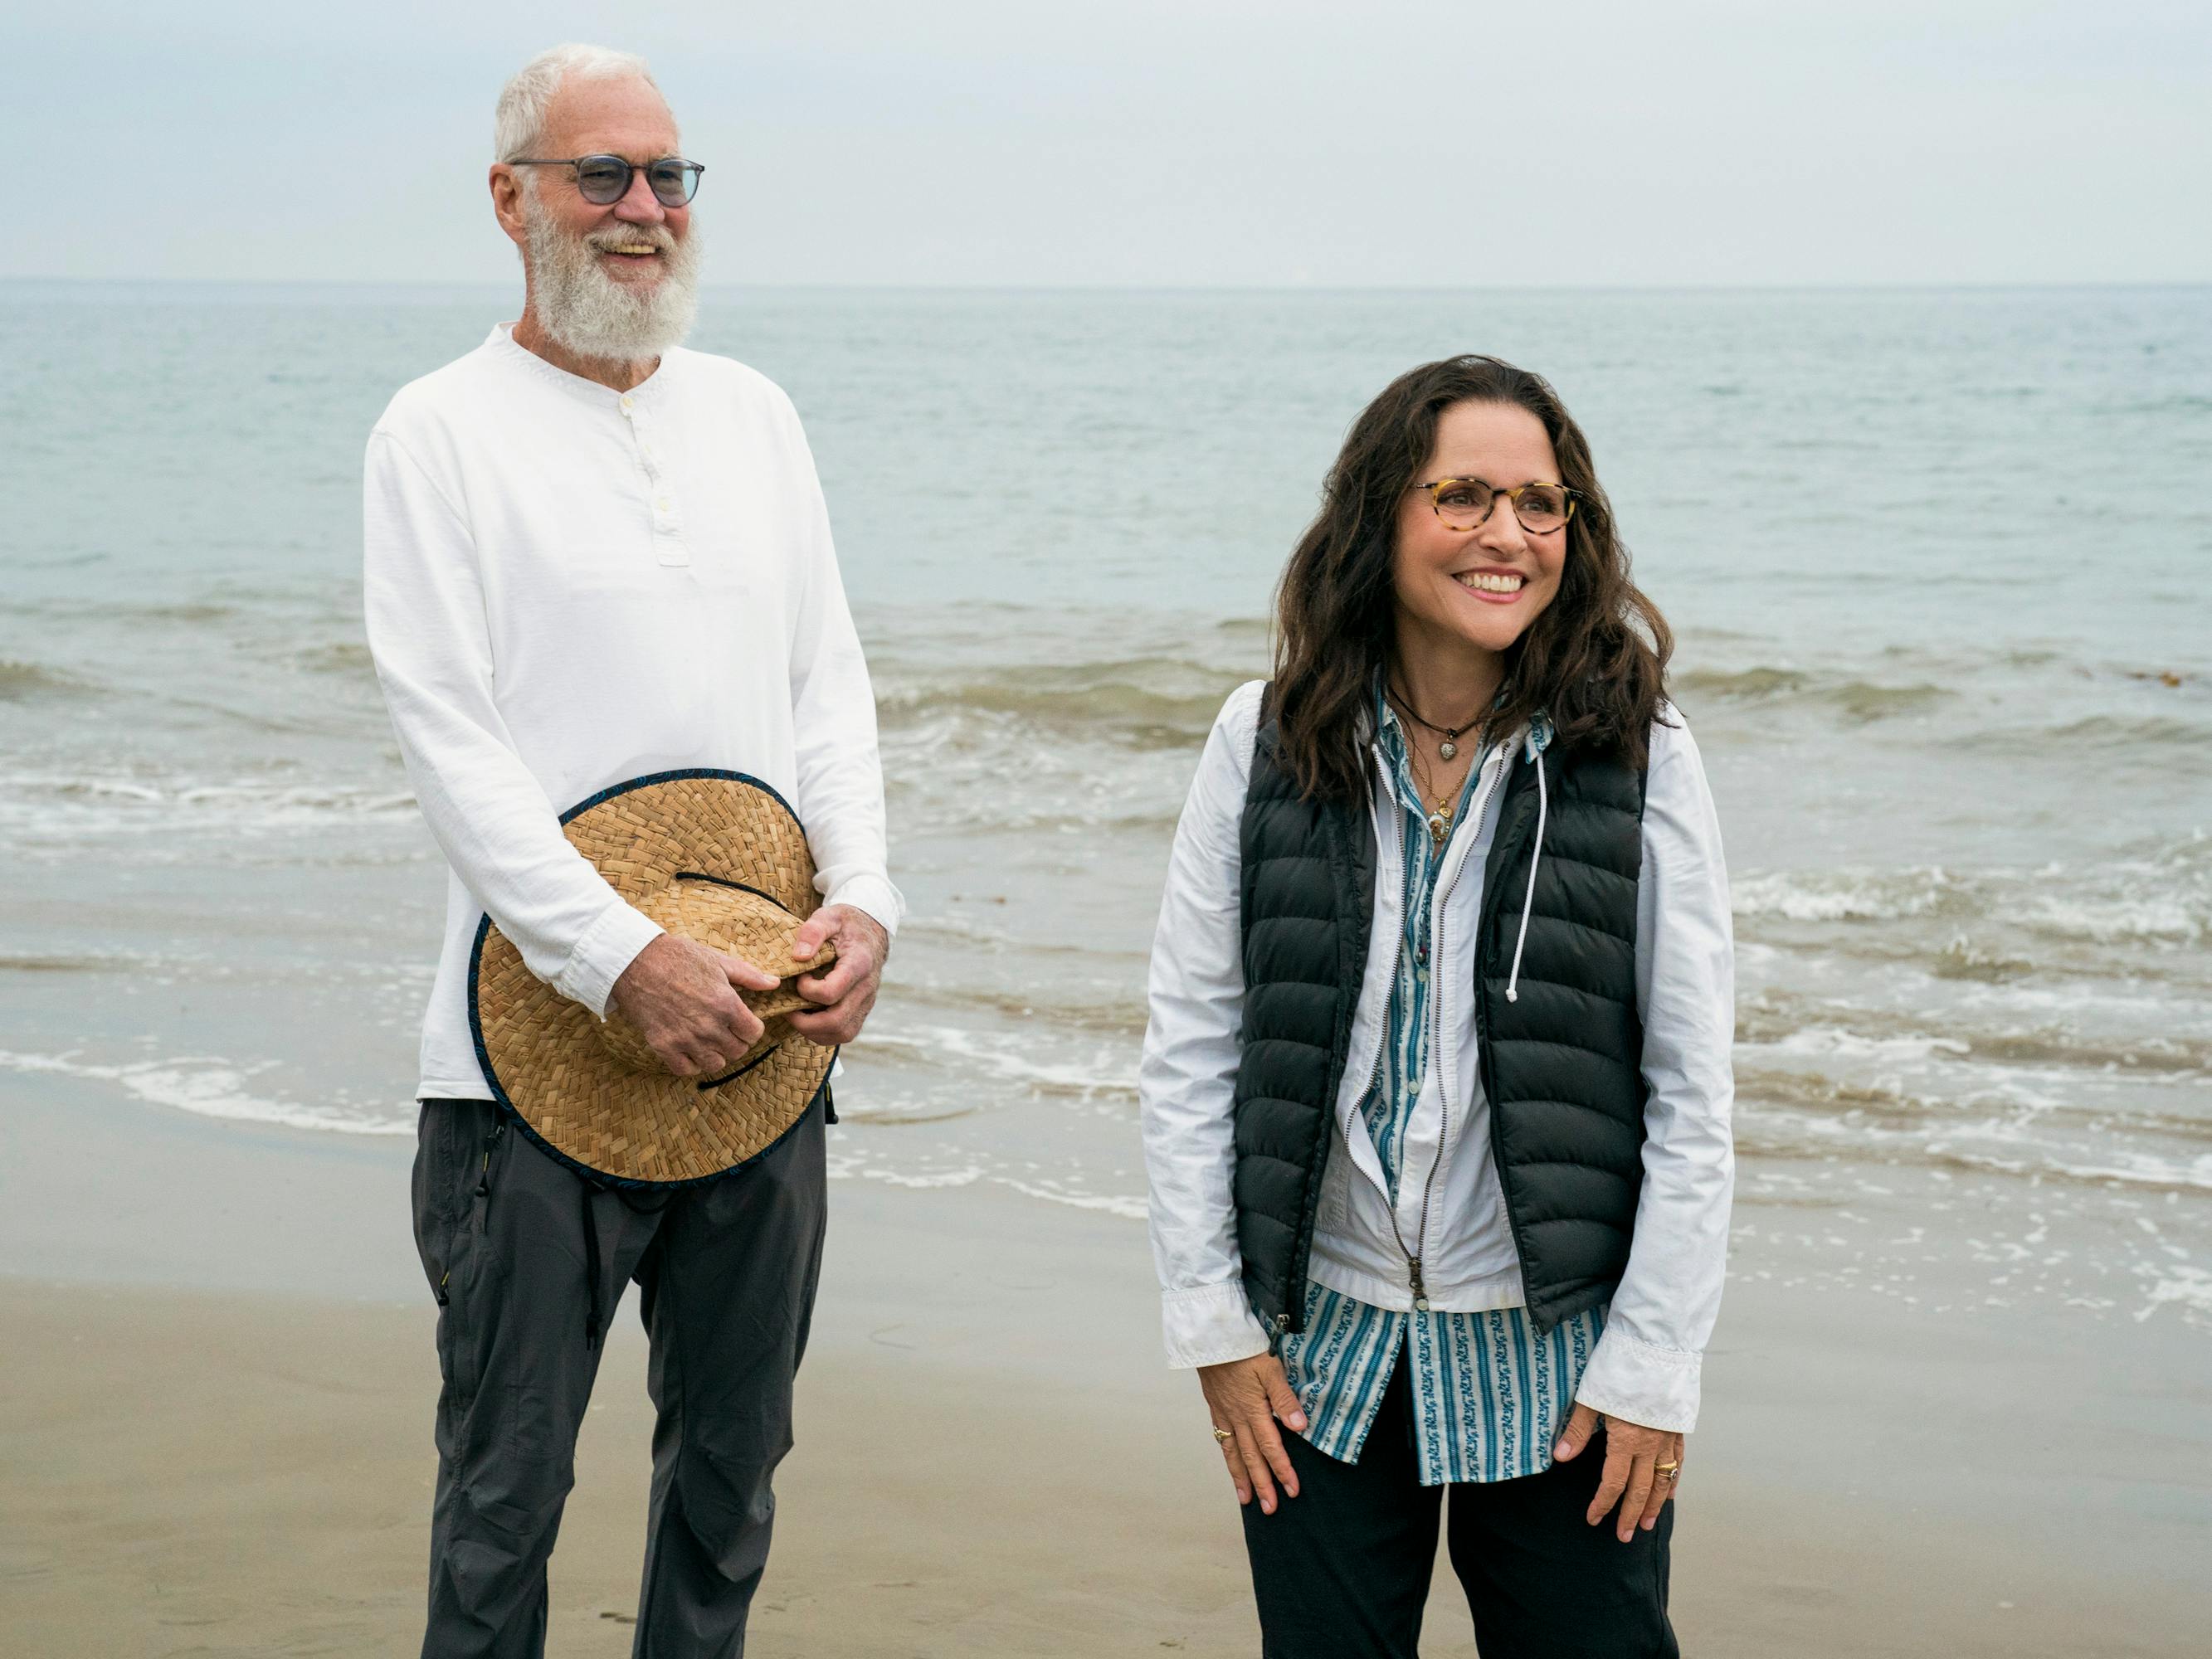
top-left (414, 1099), bottom-right (827, 1659)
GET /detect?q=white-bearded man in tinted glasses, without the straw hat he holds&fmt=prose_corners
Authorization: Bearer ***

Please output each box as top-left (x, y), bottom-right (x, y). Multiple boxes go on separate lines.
top-left (365, 46), bottom-right (903, 1659)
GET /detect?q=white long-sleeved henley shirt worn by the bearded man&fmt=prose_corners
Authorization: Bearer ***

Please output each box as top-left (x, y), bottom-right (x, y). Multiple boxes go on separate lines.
top-left (363, 323), bottom-right (904, 1099)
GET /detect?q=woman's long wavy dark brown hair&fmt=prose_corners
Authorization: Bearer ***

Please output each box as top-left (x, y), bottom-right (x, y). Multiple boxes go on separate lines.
top-left (1268, 356), bottom-right (1674, 800)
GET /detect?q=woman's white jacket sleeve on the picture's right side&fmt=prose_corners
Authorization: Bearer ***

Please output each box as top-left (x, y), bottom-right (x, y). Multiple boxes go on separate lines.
top-left (1575, 717), bottom-right (1737, 1431)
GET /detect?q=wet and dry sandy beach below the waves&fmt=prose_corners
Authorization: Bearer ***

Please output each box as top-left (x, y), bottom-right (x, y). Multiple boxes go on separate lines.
top-left (0, 1078), bottom-right (2212, 1659)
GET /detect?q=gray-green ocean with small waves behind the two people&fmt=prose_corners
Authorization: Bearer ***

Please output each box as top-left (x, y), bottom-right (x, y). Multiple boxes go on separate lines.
top-left (0, 283), bottom-right (2212, 1334)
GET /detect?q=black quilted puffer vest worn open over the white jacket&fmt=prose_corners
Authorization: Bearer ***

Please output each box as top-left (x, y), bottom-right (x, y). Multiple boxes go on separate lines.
top-left (1235, 721), bottom-right (1646, 1334)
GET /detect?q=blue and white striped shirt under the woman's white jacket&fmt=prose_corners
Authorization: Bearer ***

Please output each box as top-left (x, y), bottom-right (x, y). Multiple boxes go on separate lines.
top-left (1281, 694), bottom-right (1604, 1486)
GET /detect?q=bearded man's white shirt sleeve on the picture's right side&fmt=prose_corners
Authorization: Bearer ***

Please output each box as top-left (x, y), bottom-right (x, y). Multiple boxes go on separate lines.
top-left (783, 402), bottom-right (907, 933)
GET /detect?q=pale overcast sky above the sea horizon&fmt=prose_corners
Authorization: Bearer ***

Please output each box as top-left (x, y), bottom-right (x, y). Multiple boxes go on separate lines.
top-left (0, 0), bottom-right (2212, 288)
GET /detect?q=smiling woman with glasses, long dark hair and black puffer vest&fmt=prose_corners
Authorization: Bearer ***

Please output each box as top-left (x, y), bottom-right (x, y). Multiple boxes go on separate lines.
top-left (1142, 356), bottom-right (1734, 1659)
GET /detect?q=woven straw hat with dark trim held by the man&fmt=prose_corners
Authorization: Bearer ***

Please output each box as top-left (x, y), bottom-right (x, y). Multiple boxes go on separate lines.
top-left (469, 770), bottom-right (836, 1185)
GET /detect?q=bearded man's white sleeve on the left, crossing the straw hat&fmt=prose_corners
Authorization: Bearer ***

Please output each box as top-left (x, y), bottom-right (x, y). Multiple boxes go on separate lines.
top-left (363, 429), bottom-right (661, 1015)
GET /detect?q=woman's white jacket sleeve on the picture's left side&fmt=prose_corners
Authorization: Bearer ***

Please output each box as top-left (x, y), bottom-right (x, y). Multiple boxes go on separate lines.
top-left (1137, 681), bottom-right (1268, 1367)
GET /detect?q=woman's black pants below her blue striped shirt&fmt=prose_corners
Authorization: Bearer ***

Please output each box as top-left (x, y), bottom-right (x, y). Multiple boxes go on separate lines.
top-left (1243, 1363), bottom-right (1677, 1659)
